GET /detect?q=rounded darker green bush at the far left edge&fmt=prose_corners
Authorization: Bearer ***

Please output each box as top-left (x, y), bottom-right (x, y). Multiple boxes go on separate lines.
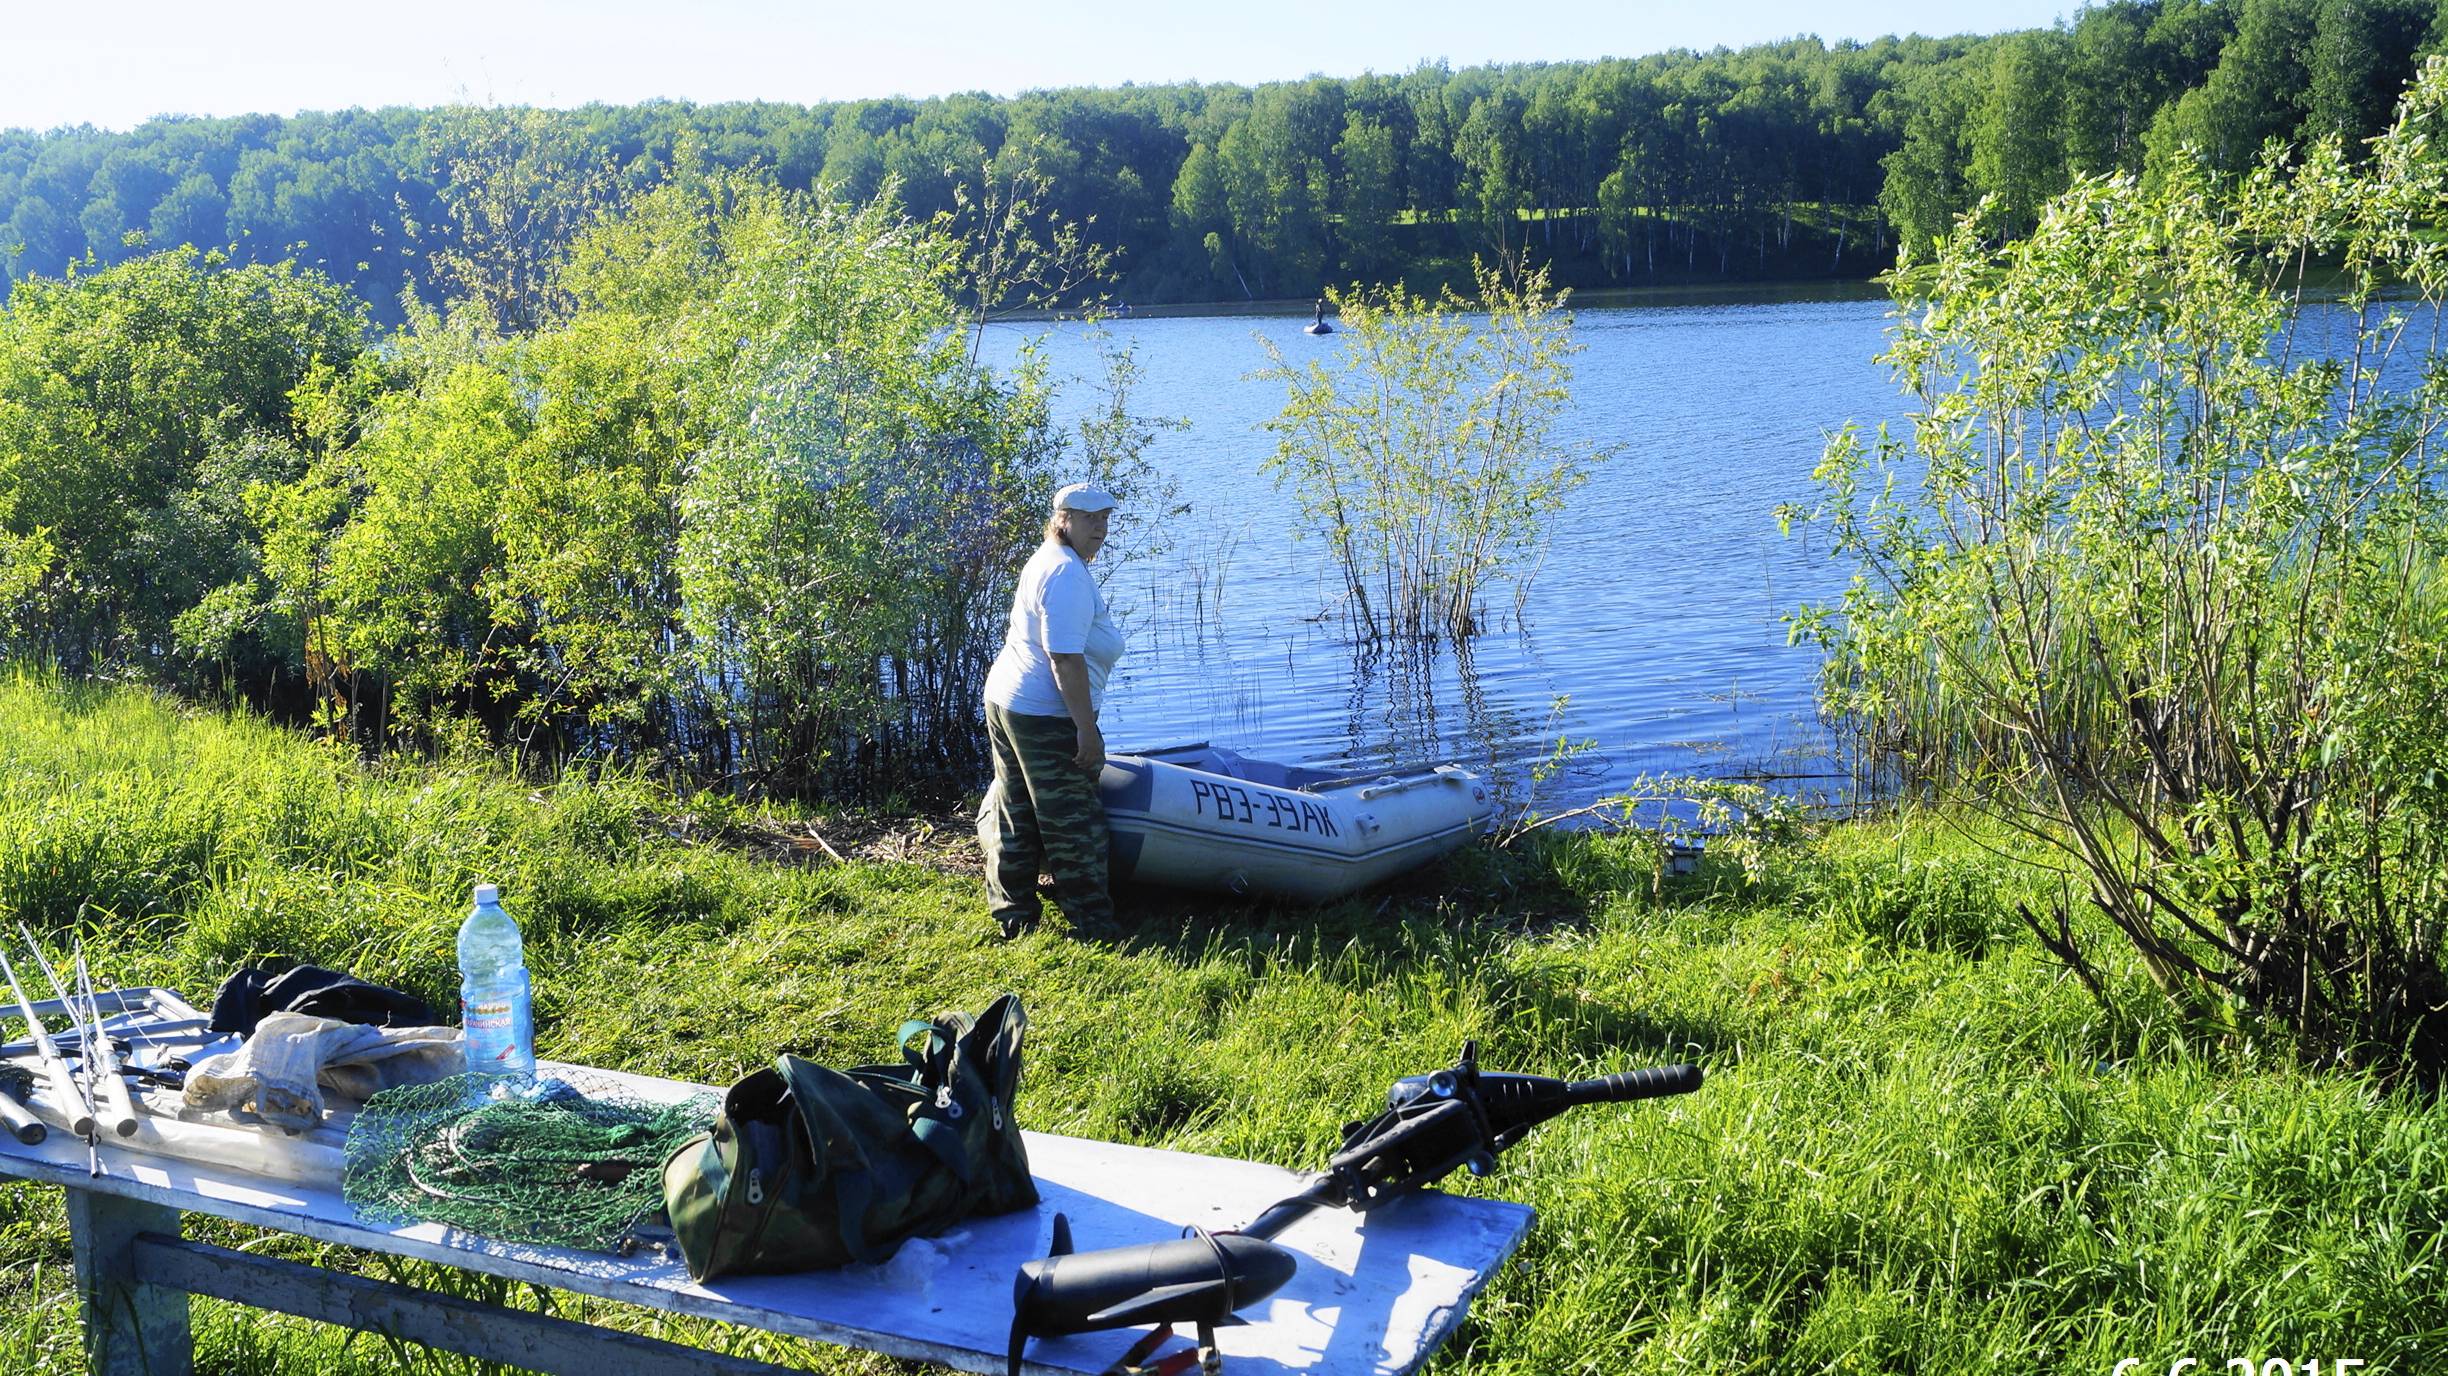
top-left (0, 247), bottom-right (365, 690)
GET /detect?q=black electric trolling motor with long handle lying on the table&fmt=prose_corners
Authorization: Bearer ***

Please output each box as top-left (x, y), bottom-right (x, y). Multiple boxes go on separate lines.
top-left (1009, 1041), bottom-right (1701, 1376)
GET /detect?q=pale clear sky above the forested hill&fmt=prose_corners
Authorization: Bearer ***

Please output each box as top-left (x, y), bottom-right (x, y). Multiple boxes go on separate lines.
top-left (0, 0), bottom-right (2076, 130)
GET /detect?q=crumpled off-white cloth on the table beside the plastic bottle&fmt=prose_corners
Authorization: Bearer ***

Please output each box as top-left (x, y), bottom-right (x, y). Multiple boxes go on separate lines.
top-left (186, 1014), bottom-right (468, 1131)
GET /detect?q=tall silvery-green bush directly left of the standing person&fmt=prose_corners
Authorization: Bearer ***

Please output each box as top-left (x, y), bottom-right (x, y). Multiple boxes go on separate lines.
top-left (678, 173), bottom-right (1053, 786)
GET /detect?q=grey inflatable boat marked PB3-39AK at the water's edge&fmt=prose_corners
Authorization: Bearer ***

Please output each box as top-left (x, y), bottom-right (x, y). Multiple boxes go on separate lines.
top-left (1097, 742), bottom-right (1496, 903)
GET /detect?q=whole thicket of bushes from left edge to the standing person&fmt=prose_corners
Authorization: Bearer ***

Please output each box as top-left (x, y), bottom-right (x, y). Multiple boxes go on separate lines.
top-left (0, 142), bottom-right (1173, 796)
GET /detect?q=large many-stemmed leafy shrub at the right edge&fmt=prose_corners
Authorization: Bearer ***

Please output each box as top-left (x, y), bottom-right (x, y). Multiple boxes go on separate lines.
top-left (1799, 61), bottom-right (2448, 1072)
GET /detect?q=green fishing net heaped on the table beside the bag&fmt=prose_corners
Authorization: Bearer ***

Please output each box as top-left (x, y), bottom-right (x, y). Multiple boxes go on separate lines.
top-left (340, 1075), bottom-right (717, 1251)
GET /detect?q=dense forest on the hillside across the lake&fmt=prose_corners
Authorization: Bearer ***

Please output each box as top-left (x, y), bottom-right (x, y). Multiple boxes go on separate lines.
top-left (0, 0), bottom-right (2448, 312)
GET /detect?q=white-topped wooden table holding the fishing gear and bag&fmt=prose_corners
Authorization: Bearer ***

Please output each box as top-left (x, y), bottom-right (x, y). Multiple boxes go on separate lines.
top-left (0, 1043), bottom-right (1532, 1376)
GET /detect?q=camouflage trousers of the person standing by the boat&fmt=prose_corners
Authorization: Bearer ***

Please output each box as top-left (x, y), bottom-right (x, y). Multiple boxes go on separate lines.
top-left (977, 703), bottom-right (1114, 935)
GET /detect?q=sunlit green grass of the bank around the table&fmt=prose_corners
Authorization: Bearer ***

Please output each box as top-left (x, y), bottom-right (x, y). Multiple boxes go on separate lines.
top-left (0, 678), bottom-right (2448, 1374)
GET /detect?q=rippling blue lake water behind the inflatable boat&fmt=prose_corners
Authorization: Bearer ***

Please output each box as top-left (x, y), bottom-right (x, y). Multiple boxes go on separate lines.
top-left (987, 284), bottom-right (1905, 813)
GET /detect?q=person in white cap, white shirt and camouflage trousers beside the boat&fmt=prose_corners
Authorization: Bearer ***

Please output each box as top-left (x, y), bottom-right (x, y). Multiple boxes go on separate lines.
top-left (977, 482), bottom-right (1121, 938)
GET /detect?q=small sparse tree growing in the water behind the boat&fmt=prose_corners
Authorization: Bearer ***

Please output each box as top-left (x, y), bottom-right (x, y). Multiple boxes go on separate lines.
top-left (1263, 264), bottom-right (1613, 639)
